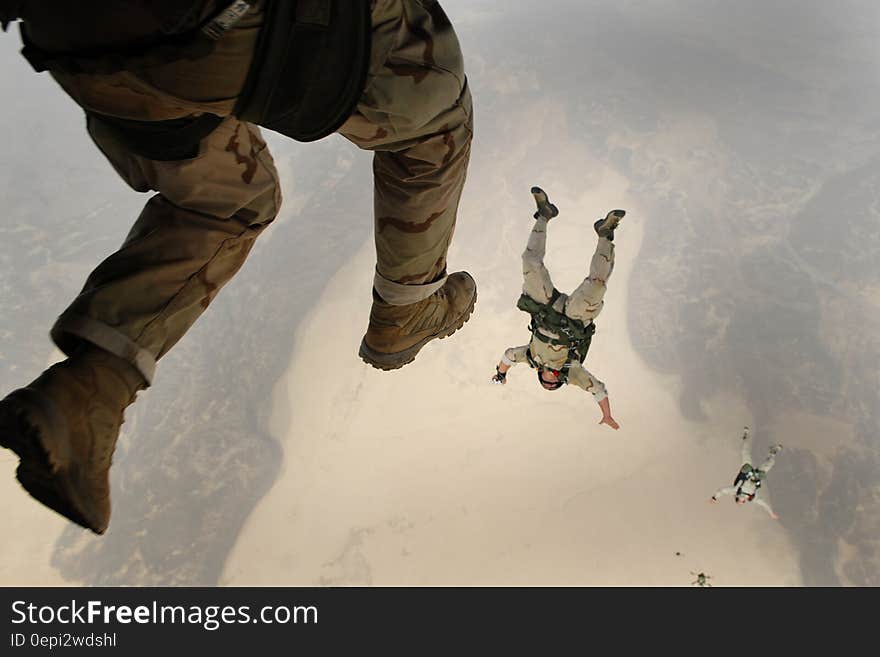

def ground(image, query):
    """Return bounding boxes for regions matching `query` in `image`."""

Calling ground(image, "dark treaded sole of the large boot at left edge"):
[0,390,106,534]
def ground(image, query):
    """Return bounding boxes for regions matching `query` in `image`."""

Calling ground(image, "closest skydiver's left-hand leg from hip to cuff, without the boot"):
[20,3,280,381]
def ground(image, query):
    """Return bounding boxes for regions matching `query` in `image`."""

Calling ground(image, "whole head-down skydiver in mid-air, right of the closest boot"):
[492,187,626,429]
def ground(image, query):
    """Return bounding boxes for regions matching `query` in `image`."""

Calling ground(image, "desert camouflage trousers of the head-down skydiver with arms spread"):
[522,218,614,323]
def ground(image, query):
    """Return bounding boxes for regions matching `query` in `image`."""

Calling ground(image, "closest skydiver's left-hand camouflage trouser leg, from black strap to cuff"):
[52,117,281,383]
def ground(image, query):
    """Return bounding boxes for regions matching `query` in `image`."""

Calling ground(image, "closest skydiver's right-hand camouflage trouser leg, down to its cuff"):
[339,0,473,305]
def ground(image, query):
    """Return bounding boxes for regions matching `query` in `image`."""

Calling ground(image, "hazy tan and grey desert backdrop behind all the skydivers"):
[0,0,880,585]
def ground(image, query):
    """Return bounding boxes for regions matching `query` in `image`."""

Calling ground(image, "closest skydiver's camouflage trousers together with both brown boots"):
[0,0,476,533]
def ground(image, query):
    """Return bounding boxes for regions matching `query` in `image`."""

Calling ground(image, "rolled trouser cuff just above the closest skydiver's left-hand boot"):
[49,313,156,387]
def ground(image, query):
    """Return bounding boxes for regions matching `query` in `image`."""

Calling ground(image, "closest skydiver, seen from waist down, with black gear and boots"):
[0,0,476,534]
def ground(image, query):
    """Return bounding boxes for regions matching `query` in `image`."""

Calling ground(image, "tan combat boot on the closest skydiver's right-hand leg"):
[359,271,477,370]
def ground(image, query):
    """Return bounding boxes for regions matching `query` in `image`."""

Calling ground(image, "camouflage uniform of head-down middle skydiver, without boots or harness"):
[501,216,614,402]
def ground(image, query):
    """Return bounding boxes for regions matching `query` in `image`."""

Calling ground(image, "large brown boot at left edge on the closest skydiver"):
[0,345,146,534]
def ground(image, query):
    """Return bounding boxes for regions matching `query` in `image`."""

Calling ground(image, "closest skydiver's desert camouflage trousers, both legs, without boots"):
[35,0,472,383]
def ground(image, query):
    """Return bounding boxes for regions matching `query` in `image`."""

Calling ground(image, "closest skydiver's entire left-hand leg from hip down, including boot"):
[0,3,280,533]
